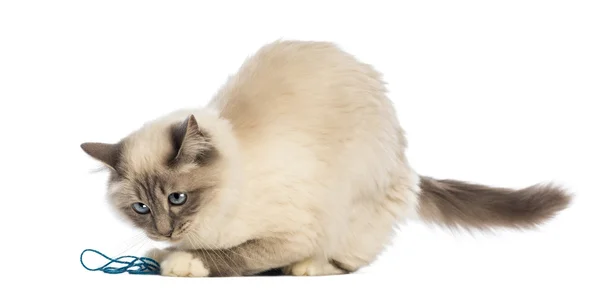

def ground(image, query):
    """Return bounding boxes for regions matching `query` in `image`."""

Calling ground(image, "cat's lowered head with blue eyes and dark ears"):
[81,112,238,242]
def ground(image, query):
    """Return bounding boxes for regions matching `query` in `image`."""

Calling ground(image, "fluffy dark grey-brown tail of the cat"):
[419,176,571,230]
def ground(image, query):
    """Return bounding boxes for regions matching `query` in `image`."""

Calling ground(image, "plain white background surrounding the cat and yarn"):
[0,0,600,289]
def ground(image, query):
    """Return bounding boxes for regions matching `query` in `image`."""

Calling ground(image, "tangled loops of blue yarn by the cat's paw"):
[79,249,160,275]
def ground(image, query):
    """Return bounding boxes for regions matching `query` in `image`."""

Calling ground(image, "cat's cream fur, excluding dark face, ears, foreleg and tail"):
[89,41,419,276]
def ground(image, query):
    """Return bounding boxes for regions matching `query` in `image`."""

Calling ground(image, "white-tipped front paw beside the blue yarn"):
[160,252,209,277]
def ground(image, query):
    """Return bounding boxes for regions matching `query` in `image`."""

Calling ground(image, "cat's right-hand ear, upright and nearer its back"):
[171,115,215,165]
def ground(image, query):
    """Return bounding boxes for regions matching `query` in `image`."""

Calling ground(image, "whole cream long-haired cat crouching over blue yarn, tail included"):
[81,40,571,277]
